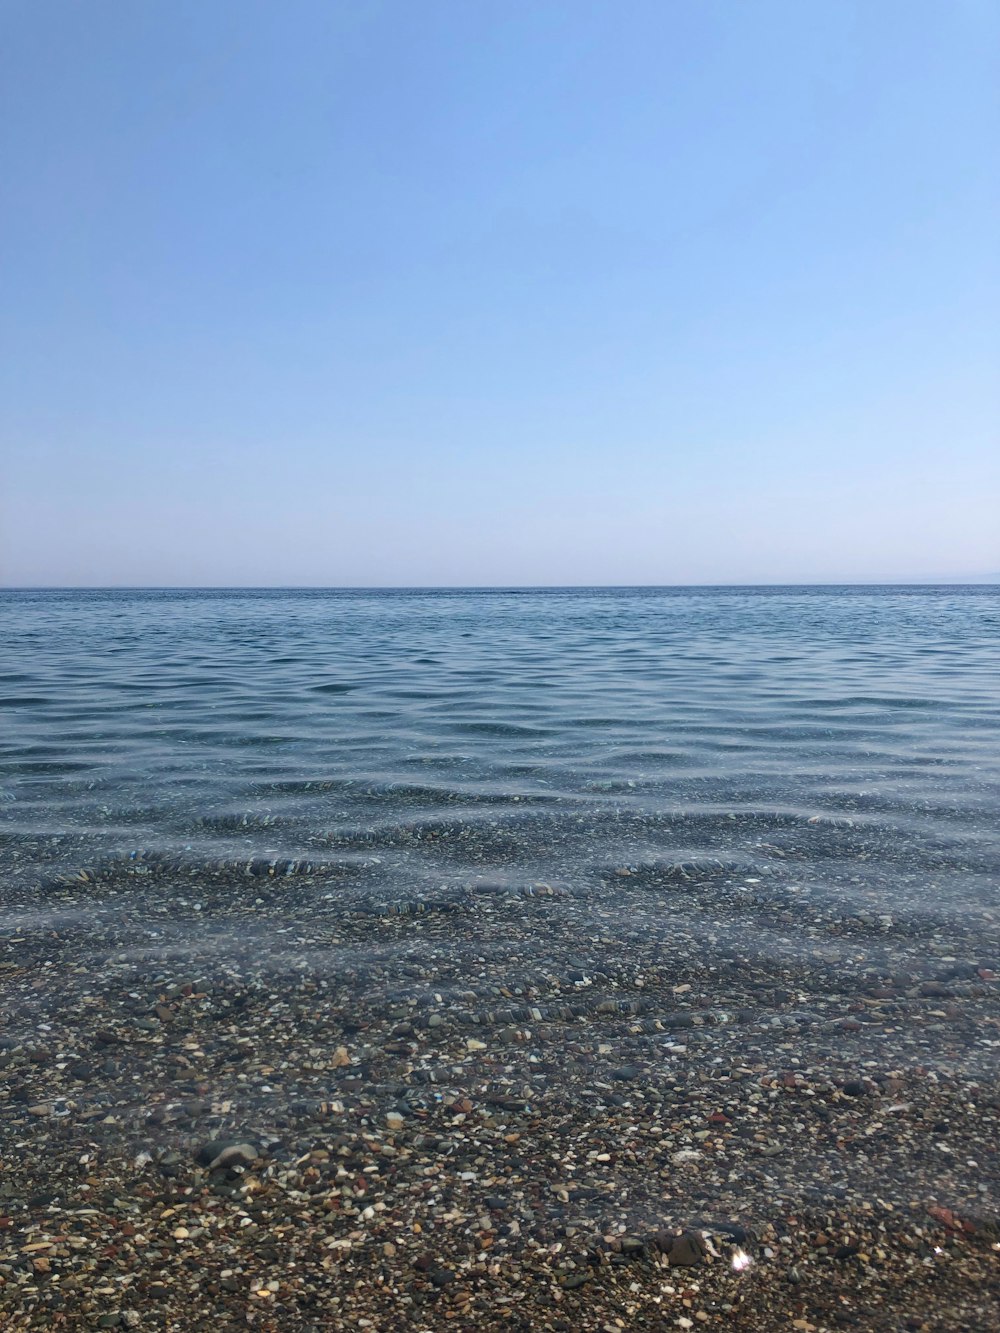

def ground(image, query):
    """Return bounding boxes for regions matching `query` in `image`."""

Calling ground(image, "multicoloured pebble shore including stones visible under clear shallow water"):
[0,857,1000,1333]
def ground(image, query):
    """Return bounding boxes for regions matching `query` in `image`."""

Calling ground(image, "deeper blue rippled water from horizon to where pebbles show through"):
[0,587,1000,917]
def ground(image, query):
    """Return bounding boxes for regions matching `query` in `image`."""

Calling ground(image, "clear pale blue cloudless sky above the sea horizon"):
[0,0,1000,585]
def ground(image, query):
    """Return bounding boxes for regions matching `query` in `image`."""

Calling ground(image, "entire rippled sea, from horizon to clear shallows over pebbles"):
[0,588,1000,1274]
